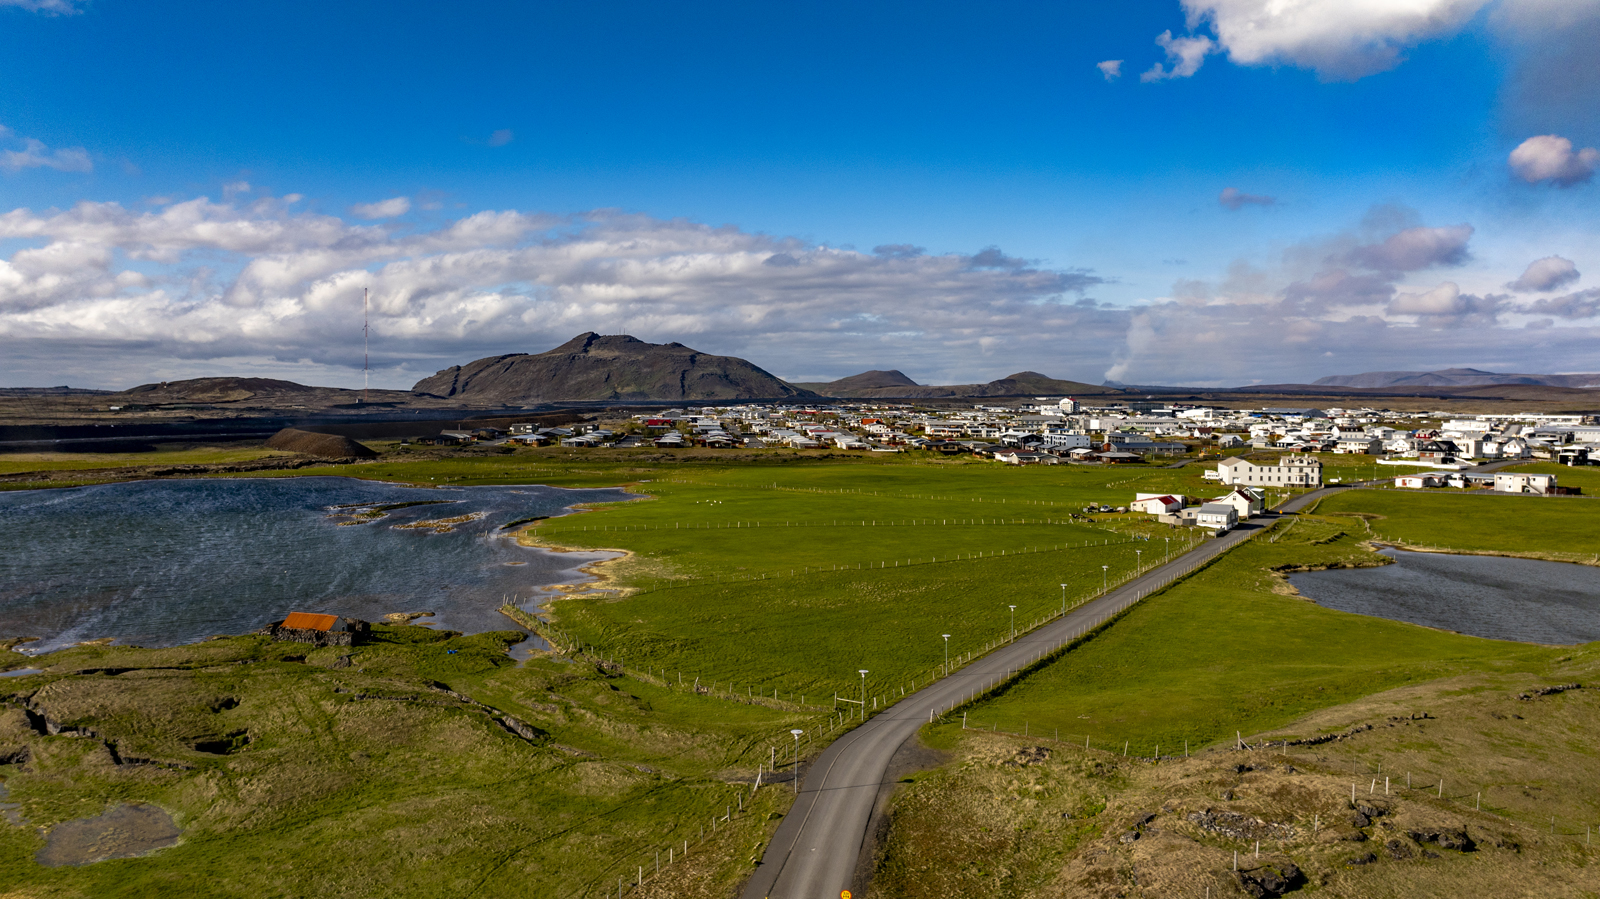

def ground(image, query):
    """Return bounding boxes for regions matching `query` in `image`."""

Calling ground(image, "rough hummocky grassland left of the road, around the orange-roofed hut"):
[0,625,811,897]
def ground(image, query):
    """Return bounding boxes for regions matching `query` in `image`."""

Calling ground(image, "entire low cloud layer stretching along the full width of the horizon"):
[0,186,1600,387]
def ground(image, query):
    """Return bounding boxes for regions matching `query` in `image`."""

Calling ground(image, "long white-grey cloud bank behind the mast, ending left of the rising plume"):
[0,190,1122,386]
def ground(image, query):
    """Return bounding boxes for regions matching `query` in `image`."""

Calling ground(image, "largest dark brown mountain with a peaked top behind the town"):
[413,331,816,399]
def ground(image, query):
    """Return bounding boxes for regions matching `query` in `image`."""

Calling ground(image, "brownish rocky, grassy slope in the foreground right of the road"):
[866,657,1600,899]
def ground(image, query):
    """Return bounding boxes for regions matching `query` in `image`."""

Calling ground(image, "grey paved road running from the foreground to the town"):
[744,488,1339,899]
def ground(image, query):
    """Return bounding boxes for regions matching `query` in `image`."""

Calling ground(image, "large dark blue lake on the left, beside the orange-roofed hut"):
[0,478,629,653]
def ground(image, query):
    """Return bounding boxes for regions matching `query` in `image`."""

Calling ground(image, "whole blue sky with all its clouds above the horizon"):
[0,0,1600,387]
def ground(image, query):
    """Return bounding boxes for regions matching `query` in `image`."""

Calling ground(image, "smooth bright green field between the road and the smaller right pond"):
[942,508,1566,755]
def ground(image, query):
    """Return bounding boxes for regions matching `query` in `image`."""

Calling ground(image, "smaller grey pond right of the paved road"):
[1290,549,1600,643]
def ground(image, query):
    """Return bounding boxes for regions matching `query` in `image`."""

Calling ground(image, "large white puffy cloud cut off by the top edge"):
[1182,0,1488,82]
